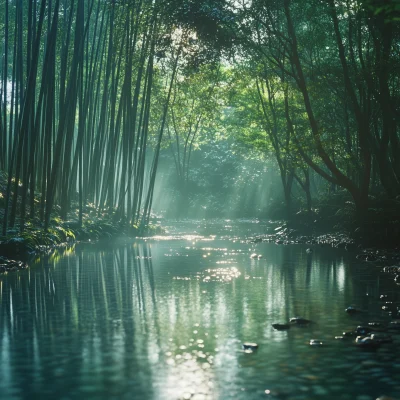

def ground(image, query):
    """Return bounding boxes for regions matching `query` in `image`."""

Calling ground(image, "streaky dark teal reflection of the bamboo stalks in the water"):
[0,244,160,398]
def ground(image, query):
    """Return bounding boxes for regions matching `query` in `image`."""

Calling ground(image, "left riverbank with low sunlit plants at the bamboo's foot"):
[0,171,166,273]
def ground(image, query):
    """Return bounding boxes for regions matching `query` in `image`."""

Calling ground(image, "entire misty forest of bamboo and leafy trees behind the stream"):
[0,0,400,234]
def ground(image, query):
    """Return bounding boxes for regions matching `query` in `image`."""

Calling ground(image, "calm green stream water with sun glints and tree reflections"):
[0,221,400,400]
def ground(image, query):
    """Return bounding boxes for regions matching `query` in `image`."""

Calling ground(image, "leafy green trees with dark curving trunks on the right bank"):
[225,0,400,217]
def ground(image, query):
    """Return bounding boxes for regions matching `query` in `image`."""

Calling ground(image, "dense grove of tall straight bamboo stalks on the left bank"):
[0,0,188,233]
